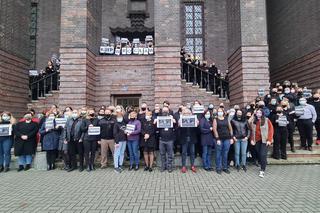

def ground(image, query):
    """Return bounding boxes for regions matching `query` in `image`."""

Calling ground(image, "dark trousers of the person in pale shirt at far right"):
[297,119,313,147]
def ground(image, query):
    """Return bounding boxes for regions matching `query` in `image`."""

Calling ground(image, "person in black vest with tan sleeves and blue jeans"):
[213,108,234,174]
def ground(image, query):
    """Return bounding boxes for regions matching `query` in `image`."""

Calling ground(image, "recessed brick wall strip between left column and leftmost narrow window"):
[36,0,61,70]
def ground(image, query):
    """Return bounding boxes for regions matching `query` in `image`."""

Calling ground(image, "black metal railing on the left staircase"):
[30,72,60,100]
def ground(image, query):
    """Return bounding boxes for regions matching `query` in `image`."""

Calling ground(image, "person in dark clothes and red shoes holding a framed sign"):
[179,108,199,173]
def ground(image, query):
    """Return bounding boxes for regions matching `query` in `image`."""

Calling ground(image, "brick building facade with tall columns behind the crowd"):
[0,0,320,113]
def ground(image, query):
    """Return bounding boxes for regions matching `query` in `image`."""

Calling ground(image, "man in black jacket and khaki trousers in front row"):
[98,109,115,169]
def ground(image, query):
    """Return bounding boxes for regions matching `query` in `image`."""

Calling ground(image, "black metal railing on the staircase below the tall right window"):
[181,60,229,99]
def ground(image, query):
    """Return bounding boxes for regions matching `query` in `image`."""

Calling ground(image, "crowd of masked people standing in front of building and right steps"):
[0,82,320,177]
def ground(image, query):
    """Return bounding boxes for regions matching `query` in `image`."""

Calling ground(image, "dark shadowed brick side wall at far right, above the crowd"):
[267,0,320,89]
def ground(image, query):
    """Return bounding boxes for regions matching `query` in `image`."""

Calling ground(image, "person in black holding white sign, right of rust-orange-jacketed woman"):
[270,106,289,160]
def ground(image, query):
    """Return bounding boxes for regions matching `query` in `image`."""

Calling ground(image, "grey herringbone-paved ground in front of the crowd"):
[0,165,320,213]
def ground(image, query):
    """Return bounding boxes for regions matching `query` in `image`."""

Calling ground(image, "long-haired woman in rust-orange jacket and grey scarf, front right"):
[250,109,274,178]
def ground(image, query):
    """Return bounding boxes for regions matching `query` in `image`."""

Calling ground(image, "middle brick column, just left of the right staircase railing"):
[154,0,182,108]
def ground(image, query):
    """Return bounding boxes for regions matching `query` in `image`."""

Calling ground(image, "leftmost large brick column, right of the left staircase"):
[59,0,101,107]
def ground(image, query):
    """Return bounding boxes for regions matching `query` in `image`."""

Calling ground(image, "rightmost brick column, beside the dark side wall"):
[227,0,270,105]
